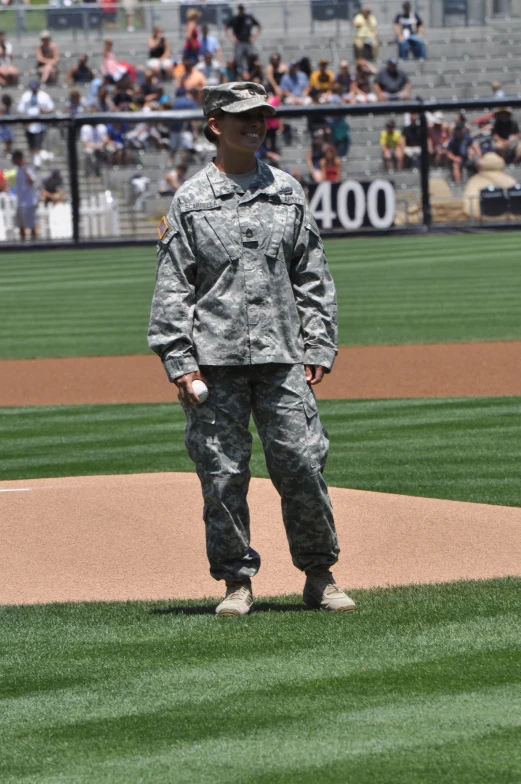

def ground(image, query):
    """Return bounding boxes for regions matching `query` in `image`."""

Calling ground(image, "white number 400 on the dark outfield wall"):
[309,180,396,230]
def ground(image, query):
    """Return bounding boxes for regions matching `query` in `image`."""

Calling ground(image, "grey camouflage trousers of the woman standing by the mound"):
[184,364,339,580]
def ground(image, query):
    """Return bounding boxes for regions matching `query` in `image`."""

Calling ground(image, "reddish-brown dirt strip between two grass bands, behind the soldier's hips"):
[0,341,521,406]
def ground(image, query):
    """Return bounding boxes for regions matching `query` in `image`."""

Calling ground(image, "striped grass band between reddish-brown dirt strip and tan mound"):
[0,397,521,506]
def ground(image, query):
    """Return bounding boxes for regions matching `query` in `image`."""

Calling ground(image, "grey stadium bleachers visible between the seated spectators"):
[0,14,521,237]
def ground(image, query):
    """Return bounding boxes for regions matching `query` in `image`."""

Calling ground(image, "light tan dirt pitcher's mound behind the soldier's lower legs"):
[0,473,521,604]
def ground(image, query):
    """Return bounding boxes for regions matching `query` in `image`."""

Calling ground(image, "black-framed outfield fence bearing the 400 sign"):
[0,98,521,244]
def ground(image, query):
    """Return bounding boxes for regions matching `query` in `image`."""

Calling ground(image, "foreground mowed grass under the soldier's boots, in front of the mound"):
[0,578,521,784]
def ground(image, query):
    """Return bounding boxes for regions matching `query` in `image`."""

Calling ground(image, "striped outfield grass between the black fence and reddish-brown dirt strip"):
[0,234,521,358]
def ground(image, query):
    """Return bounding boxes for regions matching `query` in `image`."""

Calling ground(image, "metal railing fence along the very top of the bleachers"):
[0,0,521,39]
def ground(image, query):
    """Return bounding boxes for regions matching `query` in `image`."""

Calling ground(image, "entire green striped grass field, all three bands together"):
[0,234,521,784]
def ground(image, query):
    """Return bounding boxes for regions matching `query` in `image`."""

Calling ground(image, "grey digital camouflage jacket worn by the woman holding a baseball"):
[148,162,337,381]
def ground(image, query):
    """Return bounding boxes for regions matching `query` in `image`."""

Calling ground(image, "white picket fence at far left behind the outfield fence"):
[0,191,120,242]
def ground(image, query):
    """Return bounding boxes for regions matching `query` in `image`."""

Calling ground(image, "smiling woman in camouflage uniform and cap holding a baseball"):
[149,82,355,616]
